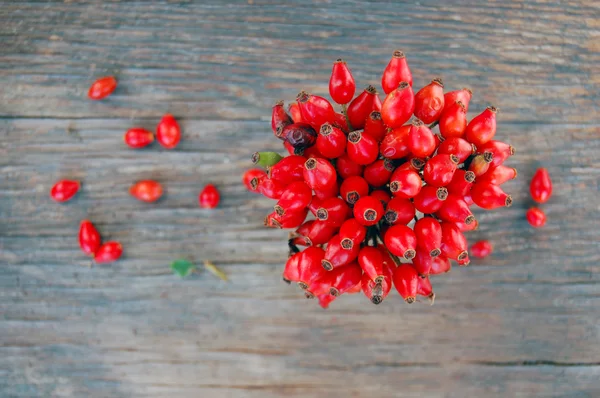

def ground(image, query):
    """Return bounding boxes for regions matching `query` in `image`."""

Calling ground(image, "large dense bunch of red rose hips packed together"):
[243,51,517,308]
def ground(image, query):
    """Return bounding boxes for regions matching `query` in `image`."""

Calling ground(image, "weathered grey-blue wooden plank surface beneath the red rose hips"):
[0,0,600,398]
